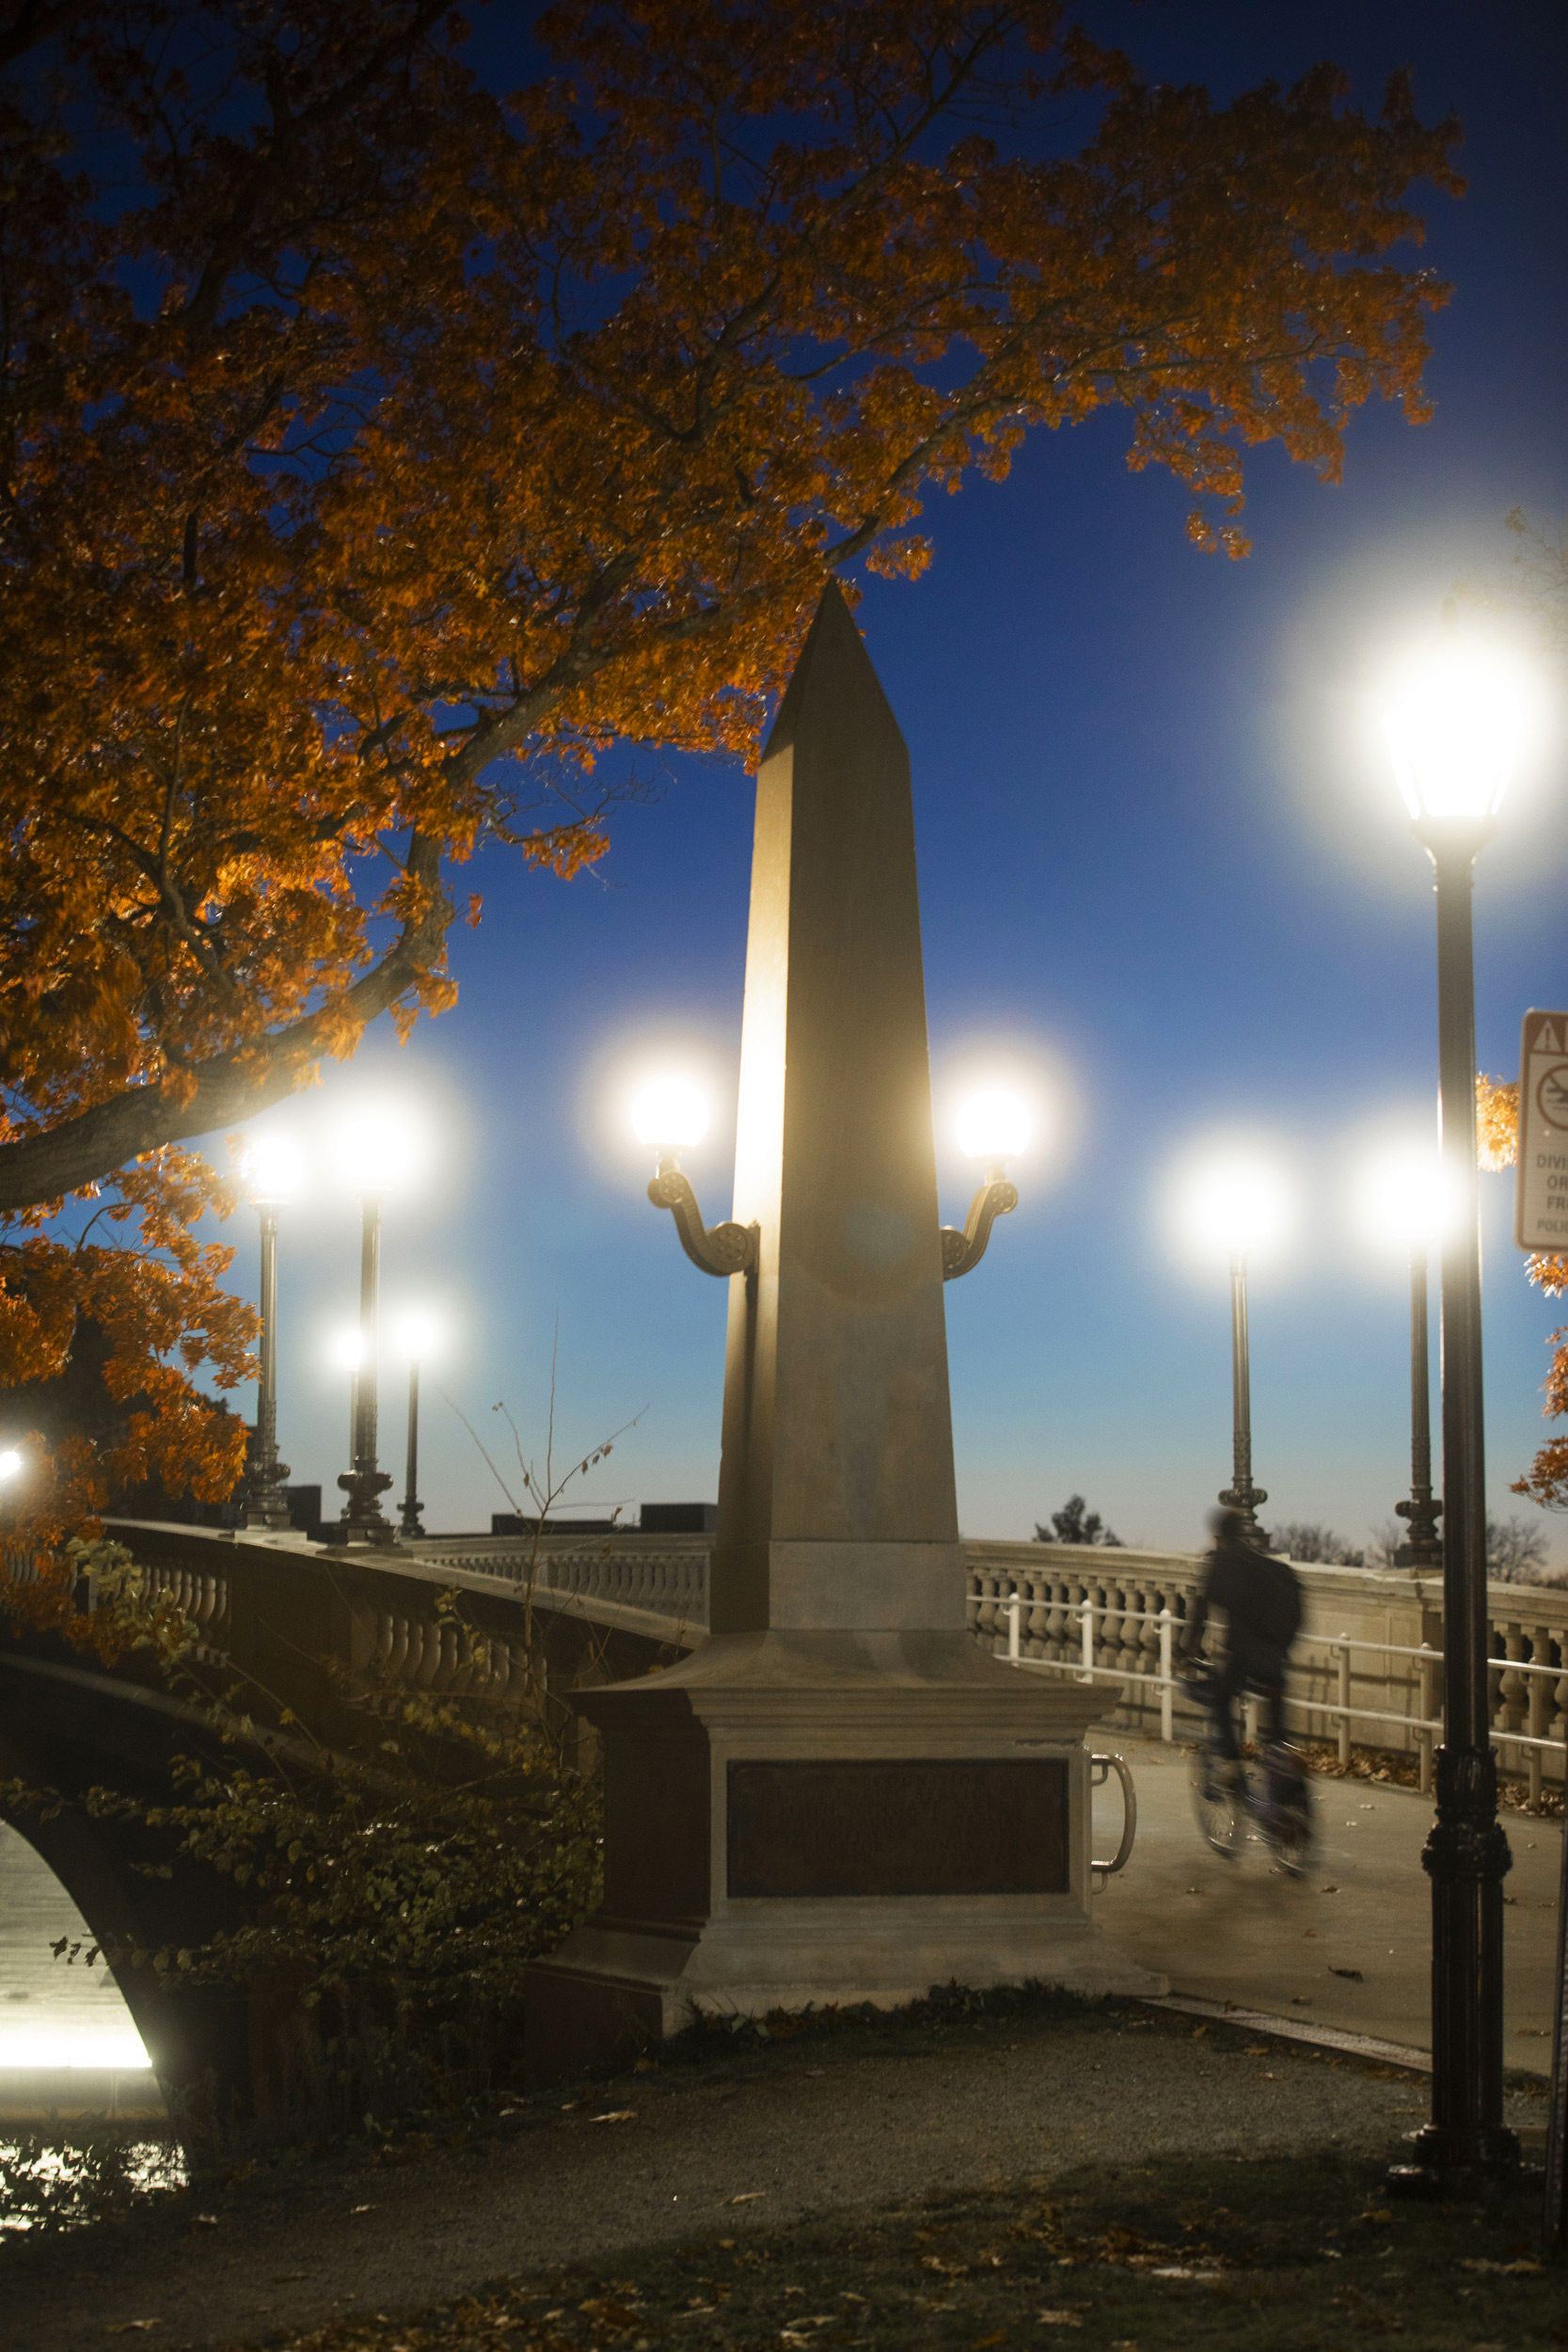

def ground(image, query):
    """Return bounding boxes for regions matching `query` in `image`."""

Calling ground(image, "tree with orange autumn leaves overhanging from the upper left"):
[0,0,1458,1510]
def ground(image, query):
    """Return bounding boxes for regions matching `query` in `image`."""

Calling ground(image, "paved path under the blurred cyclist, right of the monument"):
[1088,1726,1563,2073]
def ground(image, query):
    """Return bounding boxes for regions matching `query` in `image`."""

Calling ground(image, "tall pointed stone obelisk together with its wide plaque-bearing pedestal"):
[527,586,1164,2070]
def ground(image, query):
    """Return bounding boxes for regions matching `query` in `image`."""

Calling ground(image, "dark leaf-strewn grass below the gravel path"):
[247,2157,1568,2352]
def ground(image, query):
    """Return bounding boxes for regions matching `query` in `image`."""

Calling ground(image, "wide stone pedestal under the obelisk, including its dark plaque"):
[527,1632,1168,2079]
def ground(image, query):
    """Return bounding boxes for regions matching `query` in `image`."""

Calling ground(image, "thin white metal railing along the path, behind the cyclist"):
[992,1590,1568,1804]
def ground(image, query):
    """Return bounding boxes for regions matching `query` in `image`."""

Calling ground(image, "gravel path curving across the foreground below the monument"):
[0,1997,1543,2352]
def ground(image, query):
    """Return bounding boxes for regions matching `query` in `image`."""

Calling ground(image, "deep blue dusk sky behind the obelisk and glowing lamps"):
[242,0,1568,1557]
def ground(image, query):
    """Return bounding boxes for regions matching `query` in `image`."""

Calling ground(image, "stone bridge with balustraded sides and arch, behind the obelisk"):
[0,1522,1568,2115]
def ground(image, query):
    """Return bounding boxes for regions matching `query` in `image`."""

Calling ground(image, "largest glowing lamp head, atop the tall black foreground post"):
[1383,640,1530,828]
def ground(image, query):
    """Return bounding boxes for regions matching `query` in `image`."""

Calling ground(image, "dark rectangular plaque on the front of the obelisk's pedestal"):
[729,1757,1068,1896]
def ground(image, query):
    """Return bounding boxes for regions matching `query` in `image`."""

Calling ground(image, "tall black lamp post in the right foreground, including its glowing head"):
[1385,633,1519,2192]
